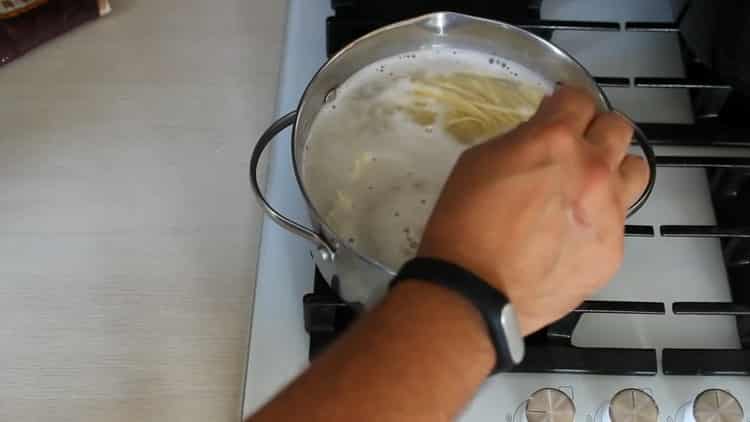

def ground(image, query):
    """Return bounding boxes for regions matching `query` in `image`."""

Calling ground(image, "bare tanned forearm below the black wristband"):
[250,282,495,422]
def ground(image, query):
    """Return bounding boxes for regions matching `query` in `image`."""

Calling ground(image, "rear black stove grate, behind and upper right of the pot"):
[326,0,750,146]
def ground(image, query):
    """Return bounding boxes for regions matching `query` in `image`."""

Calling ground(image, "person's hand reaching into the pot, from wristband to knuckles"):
[418,87,648,335]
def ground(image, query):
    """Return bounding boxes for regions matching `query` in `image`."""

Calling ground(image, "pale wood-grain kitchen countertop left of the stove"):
[0,0,286,422]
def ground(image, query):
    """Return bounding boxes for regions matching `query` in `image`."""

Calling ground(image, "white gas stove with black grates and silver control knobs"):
[244,0,750,422]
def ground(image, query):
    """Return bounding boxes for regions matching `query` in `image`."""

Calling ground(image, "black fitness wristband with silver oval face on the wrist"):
[391,258,524,374]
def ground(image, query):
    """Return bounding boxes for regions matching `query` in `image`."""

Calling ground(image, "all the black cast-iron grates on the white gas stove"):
[303,0,750,375]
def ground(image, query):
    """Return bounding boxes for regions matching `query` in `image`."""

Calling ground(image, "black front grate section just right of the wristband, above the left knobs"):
[513,300,665,375]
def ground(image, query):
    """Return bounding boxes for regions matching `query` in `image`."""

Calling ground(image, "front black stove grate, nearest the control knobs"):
[303,270,750,375]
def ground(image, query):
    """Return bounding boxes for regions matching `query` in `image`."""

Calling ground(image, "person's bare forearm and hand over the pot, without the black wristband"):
[251,87,648,422]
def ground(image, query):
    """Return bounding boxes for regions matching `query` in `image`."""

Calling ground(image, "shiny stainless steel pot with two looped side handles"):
[250,12,656,306]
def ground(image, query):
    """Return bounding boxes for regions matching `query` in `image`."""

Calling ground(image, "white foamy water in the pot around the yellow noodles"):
[303,48,552,270]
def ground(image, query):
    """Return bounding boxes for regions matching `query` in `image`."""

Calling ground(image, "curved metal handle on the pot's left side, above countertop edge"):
[250,111,334,260]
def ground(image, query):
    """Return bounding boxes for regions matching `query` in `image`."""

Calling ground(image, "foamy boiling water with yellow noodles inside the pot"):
[303,48,551,270]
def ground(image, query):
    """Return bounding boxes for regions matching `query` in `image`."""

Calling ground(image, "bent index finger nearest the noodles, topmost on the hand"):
[529,85,596,136]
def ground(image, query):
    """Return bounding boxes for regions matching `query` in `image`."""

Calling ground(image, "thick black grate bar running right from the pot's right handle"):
[638,123,750,147]
